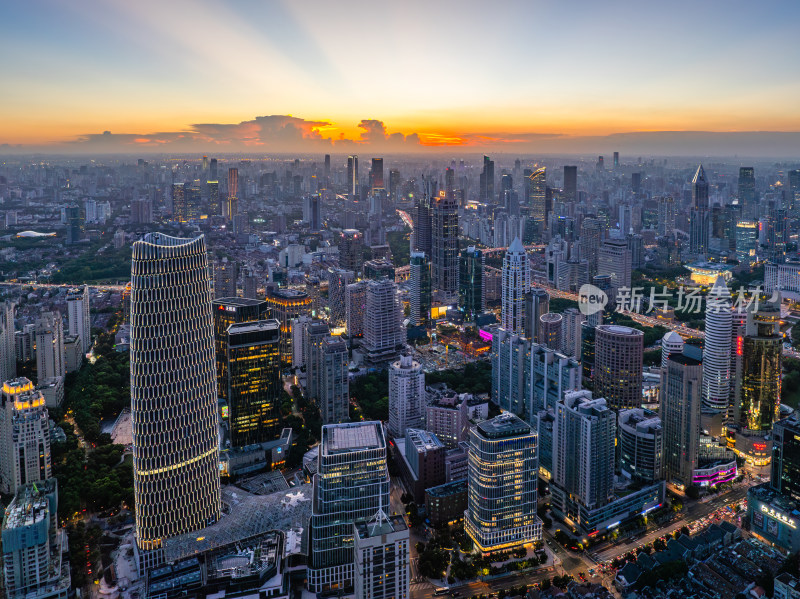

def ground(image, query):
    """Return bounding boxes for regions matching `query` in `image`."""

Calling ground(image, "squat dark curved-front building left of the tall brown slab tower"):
[617,408,664,483]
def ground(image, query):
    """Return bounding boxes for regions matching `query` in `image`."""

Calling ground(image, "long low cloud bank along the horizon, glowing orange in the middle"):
[0,115,800,158]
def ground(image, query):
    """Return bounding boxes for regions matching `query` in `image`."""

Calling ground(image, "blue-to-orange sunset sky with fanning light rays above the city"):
[0,0,800,151]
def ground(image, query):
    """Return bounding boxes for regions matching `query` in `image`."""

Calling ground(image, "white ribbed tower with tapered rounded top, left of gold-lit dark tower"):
[703,275,733,413]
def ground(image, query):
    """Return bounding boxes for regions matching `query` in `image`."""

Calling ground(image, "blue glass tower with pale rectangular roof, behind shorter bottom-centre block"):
[307,422,389,593]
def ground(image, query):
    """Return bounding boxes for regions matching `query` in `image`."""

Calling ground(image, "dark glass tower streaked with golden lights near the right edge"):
[734,292,783,436]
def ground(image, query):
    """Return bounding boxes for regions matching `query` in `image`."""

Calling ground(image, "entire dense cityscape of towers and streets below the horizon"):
[0,152,800,599]
